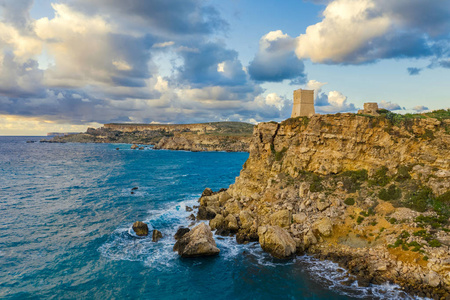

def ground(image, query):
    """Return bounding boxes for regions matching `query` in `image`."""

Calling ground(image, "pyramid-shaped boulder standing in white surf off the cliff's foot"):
[173,223,220,257]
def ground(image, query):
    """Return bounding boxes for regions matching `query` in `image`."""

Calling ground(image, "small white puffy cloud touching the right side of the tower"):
[305,80,356,114]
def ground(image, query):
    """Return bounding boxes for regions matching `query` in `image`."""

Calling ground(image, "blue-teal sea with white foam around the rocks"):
[0,137,420,299]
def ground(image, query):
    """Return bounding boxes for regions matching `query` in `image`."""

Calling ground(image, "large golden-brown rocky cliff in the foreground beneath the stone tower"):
[198,110,450,298]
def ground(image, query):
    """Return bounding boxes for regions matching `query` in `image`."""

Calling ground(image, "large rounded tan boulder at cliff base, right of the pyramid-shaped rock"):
[258,225,296,258]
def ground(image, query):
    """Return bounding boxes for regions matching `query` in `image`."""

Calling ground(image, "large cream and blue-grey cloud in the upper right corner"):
[296,0,450,64]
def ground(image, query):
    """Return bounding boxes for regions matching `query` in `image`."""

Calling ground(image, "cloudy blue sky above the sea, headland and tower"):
[0,0,450,135]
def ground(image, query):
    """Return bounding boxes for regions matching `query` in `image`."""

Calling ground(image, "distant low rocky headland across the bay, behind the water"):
[51,122,254,151]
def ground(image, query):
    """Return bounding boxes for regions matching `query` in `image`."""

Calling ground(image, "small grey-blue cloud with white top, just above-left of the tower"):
[248,30,306,84]
